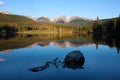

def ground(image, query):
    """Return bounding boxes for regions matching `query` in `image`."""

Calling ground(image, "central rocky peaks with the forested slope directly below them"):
[37,16,95,27]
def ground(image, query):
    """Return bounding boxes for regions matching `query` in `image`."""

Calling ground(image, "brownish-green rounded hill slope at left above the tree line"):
[0,13,34,23]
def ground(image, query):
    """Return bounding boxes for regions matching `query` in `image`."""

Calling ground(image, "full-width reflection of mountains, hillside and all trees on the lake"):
[0,34,120,53]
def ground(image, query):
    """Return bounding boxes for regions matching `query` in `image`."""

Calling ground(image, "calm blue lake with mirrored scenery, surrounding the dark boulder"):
[0,34,120,80]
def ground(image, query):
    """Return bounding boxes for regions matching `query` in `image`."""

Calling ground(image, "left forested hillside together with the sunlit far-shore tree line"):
[0,13,92,35]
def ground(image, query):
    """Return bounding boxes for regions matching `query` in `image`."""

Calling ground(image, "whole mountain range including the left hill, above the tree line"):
[0,11,117,27]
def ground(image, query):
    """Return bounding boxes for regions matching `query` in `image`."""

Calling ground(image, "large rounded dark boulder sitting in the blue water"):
[63,51,85,69]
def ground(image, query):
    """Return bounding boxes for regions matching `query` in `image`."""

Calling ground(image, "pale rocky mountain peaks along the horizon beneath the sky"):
[0,11,96,23]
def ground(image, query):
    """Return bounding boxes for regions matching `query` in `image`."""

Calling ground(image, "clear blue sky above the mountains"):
[0,0,120,18]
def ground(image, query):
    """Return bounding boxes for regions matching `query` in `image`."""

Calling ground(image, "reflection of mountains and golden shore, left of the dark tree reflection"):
[0,34,92,52]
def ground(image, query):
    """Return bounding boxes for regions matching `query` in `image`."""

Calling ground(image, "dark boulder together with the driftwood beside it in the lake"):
[29,51,85,72]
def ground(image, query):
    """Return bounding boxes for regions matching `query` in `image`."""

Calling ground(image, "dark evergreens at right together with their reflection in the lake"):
[93,17,120,52]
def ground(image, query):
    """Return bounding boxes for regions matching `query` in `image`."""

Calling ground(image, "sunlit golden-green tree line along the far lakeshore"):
[0,22,92,34]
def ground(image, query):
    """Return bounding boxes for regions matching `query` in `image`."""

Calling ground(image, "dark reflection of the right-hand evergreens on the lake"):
[92,34,120,53]
